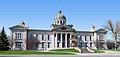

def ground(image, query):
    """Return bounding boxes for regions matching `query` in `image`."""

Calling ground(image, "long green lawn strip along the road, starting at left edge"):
[0,50,74,55]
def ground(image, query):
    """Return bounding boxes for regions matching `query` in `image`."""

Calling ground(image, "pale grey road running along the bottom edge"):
[0,54,120,57]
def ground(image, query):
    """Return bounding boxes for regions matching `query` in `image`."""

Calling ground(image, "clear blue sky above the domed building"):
[0,0,120,39]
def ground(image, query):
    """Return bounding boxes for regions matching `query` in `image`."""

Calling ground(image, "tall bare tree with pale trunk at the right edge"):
[104,20,120,50]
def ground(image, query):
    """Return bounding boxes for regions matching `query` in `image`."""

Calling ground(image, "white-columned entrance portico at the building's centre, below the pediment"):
[54,32,71,48]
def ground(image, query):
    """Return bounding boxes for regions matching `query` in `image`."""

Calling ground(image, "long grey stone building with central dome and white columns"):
[9,10,107,50]
